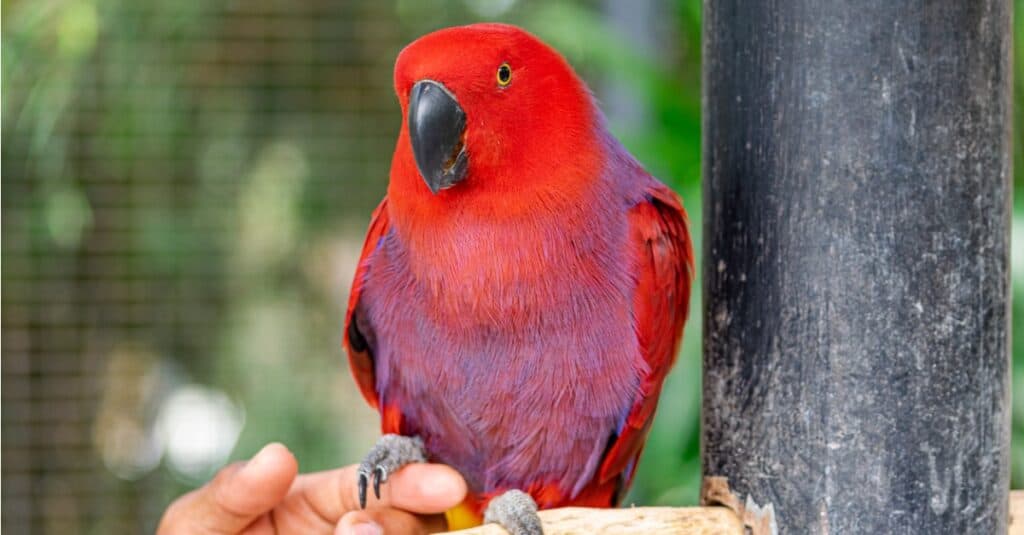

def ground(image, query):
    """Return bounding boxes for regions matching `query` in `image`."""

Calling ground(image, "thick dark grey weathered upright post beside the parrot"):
[703,0,1012,533]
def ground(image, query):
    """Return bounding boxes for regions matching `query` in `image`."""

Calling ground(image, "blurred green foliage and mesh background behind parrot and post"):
[2,0,1024,534]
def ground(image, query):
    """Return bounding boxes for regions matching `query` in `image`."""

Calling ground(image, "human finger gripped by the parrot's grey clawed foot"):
[296,463,466,524]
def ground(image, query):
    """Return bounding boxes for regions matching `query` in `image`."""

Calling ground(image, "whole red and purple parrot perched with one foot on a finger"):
[345,24,693,535]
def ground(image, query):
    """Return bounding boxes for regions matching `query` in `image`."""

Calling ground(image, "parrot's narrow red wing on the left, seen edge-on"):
[345,197,390,408]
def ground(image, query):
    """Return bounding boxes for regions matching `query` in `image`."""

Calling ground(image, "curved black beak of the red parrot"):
[409,80,469,194]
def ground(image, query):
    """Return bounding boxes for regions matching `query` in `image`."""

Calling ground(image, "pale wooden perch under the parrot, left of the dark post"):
[451,507,743,535]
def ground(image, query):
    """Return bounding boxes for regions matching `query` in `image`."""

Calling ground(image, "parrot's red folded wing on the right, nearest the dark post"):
[598,180,693,488]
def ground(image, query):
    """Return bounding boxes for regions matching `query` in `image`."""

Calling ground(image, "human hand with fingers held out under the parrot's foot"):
[157,443,466,535]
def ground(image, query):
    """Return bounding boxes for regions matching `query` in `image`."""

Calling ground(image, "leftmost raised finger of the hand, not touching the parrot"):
[161,444,298,534]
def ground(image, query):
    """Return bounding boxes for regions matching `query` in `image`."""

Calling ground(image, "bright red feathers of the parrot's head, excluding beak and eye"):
[388,24,599,228]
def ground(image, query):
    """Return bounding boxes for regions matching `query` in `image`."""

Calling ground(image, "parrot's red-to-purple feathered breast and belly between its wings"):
[362,179,643,507]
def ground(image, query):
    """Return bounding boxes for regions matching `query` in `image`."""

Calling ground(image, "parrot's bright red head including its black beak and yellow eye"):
[391,24,600,199]
